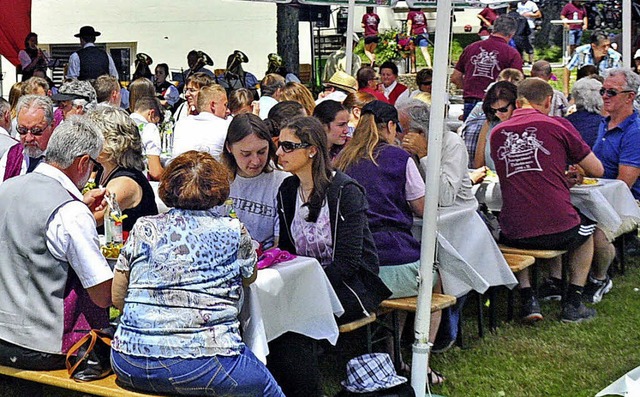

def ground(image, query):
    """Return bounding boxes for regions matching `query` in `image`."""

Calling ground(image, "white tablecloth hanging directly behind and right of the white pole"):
[413,204,518,297]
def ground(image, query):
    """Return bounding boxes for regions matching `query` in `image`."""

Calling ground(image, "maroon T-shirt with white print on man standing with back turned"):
[456,35,522,100]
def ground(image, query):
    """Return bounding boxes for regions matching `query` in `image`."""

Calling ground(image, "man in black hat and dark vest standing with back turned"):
[66,26,118,80]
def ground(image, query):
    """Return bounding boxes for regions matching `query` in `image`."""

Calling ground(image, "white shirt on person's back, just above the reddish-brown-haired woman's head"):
[171,112,231,160]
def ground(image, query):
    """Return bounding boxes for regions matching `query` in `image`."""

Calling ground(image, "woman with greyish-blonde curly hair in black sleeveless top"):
[88,105,158,234]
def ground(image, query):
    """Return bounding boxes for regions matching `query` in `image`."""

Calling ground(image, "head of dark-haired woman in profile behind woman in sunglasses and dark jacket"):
[313,100,349,161]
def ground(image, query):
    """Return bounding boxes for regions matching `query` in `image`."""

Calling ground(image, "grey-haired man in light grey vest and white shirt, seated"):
[0,117,113,370]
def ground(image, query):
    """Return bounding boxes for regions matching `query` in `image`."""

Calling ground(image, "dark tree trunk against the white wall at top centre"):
[277,4,300,76]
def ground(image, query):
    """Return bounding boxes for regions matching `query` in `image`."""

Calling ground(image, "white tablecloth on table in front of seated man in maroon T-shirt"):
[476,179,640,240]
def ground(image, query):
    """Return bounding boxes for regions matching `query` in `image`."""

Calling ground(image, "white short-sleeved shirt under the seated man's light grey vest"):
[33,163,113,288]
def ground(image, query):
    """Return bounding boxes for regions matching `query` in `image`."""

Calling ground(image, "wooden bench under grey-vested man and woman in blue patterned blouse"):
[0,365,162,397]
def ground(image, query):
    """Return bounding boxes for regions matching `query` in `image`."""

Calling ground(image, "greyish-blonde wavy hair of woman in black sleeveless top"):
[87,104,144,171]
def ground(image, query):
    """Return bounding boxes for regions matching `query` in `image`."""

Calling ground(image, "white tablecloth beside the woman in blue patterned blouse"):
[240,256,344,362]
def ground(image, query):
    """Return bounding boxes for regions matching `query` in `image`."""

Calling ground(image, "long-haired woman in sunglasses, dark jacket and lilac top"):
[267,116,391,397]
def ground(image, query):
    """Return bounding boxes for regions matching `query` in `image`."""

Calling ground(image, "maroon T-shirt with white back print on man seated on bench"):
[490,109,591,239]
